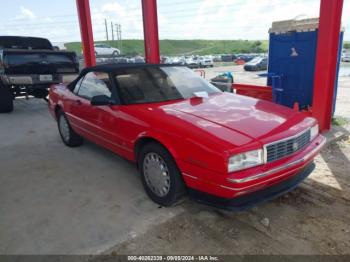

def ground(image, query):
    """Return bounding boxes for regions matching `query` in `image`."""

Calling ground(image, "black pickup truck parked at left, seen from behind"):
[0,36,79,113]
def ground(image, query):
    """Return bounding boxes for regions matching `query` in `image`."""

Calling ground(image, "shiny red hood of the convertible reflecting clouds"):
[163,93,306,140]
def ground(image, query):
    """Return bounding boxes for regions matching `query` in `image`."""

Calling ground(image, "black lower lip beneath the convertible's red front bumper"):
[189,162,315,211]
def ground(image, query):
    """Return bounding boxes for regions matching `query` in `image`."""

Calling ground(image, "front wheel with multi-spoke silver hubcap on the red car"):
[138,142,185,206]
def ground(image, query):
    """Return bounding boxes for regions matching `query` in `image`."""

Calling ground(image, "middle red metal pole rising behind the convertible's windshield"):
[141,0,160,64]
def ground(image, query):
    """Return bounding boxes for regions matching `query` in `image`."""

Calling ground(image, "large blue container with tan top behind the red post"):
[268,18,343,109]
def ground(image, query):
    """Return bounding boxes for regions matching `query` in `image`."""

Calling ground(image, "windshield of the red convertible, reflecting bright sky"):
[115,66,221,104]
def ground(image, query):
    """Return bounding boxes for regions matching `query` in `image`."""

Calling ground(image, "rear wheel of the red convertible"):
[57,111,84,147]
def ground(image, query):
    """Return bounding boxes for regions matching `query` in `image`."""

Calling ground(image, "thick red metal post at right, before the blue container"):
[312,0,343,132]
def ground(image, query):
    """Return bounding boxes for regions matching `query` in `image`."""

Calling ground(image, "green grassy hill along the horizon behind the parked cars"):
[66,39,268,56]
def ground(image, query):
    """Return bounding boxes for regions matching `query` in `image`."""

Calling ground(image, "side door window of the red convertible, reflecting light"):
[78,72,112,100]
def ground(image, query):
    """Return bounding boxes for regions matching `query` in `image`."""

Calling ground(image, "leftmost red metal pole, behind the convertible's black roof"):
[76,0,96,67]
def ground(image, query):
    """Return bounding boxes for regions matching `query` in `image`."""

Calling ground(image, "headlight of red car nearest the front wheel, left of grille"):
[228,149,264,172]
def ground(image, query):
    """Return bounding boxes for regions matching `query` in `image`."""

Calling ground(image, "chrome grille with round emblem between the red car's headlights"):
[265,130,311,163]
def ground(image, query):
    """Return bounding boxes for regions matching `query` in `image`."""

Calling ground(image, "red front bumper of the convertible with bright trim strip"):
[181,135,326,199]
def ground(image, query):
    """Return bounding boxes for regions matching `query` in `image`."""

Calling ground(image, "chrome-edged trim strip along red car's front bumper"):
[227,136,327,184]
